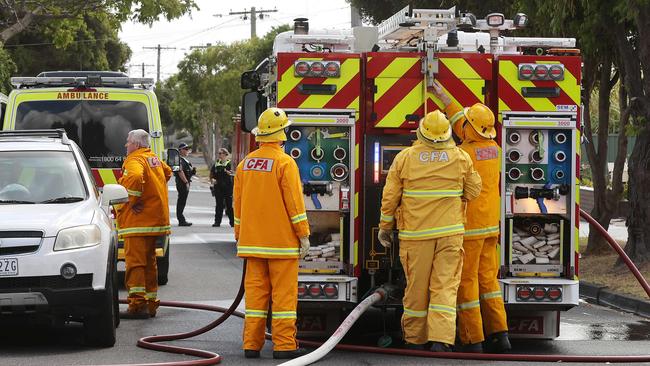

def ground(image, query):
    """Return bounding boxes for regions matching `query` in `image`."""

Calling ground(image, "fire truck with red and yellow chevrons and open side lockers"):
[233,6,581,339]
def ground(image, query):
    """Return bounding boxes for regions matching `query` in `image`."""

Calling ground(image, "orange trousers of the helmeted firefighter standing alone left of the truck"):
[244,257,298,351]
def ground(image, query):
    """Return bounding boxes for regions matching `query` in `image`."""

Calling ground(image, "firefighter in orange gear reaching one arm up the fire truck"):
[433,82,511,353]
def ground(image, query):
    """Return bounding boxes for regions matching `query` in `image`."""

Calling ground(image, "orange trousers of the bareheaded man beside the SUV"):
[124,236,160,313]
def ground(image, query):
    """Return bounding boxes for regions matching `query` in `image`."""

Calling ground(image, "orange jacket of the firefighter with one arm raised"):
[445,102,501,240]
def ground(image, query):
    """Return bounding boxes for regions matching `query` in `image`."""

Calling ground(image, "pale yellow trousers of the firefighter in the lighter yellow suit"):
[399,235,463,344]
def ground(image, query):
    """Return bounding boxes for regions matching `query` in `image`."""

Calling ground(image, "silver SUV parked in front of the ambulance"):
[0,130,127,347]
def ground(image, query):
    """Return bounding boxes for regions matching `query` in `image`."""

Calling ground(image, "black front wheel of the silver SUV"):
[84,271,119,347]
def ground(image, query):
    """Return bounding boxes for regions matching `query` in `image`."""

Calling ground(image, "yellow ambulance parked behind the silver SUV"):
[3,71,169,285]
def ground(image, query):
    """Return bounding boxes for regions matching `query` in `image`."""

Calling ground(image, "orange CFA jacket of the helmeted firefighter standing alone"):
[233,143,309,258]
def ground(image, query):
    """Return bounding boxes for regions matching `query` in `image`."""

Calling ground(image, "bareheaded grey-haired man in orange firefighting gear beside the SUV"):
[117,130,172,319]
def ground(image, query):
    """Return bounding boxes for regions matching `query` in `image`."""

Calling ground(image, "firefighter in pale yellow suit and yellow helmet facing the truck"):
[379,111,481,352]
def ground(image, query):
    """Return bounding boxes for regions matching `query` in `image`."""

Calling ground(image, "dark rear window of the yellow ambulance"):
[15,100,149,169]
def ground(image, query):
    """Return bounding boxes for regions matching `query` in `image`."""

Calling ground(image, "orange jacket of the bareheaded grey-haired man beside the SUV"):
[117,148,172,238]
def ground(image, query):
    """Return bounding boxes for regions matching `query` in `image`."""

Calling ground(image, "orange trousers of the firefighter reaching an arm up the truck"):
[458,236,508,344]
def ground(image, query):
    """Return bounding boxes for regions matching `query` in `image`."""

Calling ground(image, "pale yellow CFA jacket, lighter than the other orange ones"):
[379,140,481,240]
